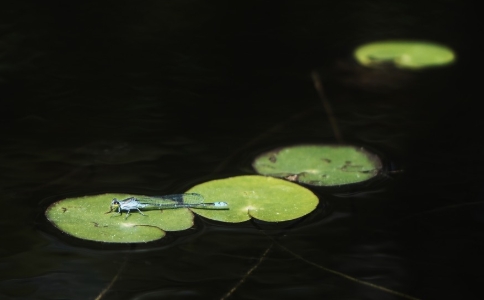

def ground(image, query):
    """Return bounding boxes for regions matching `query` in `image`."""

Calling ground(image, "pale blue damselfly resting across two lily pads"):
[106,193,229,219]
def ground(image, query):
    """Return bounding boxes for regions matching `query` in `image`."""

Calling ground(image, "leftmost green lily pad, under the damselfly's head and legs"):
[45,194,194,243]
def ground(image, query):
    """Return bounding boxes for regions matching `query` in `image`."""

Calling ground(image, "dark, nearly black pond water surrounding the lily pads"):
[0,1,484,299]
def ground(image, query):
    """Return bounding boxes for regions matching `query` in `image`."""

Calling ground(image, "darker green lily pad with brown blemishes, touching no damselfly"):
[252,145,382,186]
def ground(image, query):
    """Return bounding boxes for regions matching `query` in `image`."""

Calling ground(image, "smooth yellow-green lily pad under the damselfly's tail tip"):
[188,176,319,223]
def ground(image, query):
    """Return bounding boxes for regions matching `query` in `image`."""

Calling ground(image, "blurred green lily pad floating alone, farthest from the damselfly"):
[354,41,455,69]
